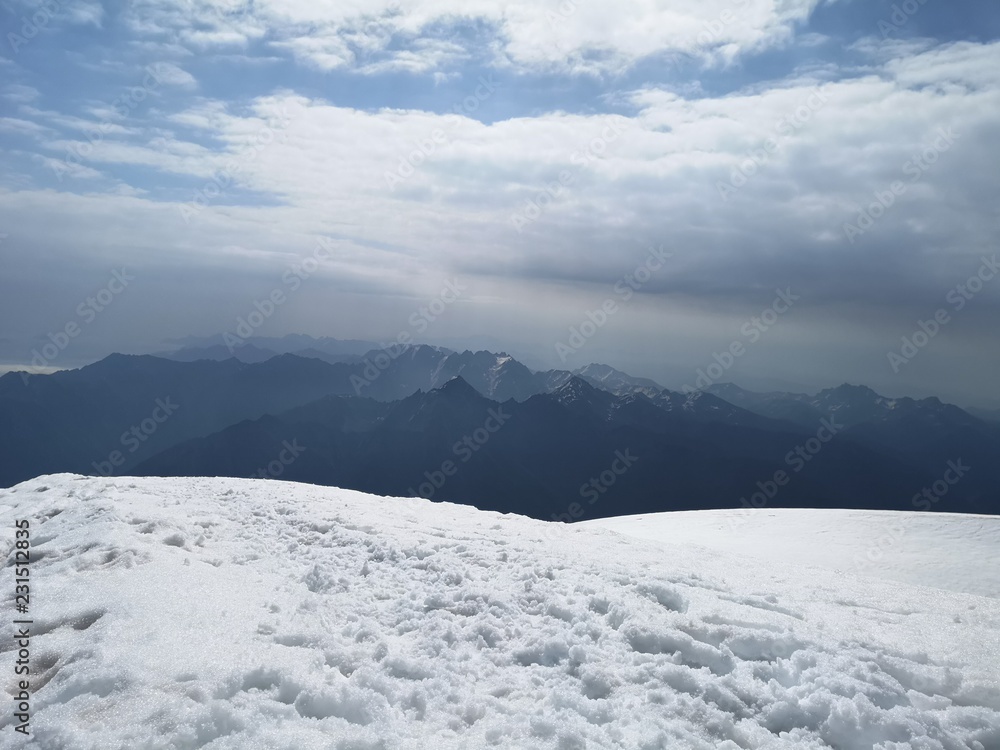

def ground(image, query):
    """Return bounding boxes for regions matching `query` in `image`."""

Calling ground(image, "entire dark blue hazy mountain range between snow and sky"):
[0,337,1000,521]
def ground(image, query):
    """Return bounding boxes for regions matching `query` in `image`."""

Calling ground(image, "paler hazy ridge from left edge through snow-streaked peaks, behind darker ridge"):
[0,354,776,492]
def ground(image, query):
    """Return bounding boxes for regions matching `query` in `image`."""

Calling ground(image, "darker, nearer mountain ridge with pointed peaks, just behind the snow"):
[131,376,944,520]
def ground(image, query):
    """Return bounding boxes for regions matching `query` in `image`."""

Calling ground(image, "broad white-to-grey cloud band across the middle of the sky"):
[0,38,1000,406]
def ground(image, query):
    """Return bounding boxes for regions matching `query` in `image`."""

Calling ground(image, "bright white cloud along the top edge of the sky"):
[123,0,819,74]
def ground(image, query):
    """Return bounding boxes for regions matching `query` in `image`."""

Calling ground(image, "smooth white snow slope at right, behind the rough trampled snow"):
[579,508,1000,598]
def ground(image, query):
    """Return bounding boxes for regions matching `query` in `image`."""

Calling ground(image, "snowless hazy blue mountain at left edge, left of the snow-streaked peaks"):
[0,354,362,485]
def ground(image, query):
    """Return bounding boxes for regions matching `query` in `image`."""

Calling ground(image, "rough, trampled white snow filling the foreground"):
[0,474,1000,750]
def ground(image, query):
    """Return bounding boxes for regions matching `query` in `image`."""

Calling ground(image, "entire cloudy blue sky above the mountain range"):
[0,0,1000,405]
